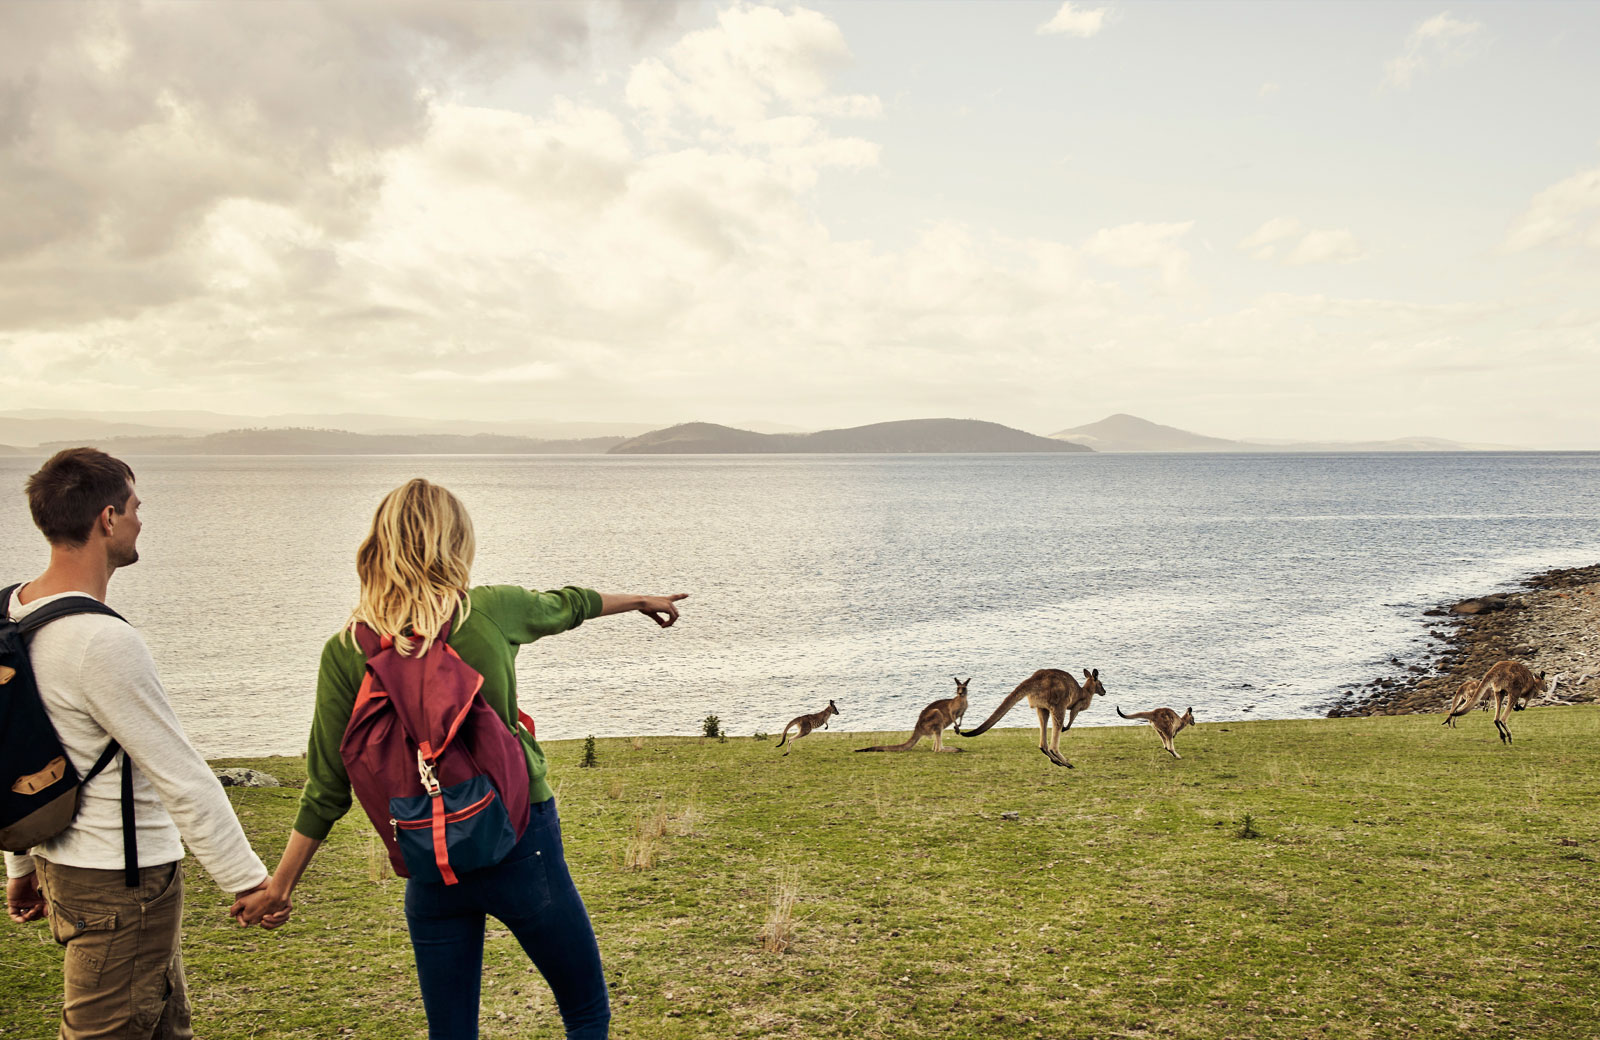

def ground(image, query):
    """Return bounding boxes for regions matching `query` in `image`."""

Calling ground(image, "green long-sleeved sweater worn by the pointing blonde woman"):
[294,586,600,842]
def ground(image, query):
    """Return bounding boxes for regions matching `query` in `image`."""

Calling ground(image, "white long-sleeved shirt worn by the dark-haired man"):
[5,592,267,893]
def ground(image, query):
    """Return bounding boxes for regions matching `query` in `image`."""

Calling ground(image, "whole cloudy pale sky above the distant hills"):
[0,0,1600,448]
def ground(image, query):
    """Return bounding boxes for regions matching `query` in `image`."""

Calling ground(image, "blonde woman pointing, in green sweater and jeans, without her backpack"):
[234,480,686,1040]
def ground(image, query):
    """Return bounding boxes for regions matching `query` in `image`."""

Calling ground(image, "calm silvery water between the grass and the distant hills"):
[0,453,1600,755]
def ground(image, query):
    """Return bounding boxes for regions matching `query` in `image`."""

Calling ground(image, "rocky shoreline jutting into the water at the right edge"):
[1328,565,1600,718]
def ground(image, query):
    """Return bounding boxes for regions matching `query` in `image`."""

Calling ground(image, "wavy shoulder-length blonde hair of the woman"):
[346,478,477,656]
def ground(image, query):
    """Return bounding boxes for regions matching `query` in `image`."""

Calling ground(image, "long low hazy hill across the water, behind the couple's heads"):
[38,429,624,454]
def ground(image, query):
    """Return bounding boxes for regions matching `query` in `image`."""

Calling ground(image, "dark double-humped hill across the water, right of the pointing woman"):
[611,419,1090,454]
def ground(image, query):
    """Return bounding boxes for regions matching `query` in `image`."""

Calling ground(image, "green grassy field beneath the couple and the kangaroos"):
[0,706,1600,1040]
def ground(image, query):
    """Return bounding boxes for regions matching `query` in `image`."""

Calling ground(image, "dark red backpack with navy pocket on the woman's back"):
[339,624,533,885]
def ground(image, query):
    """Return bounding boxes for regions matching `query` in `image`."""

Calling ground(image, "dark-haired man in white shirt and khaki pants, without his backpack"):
[3,448,267,1040]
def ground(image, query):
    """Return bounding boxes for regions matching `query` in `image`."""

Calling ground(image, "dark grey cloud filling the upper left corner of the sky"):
[0,0,681,325]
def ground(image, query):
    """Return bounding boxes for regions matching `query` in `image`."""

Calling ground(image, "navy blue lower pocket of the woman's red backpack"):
[389,774,517,885]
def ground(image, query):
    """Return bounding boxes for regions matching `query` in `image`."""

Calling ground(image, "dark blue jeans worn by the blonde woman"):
[405,798,611,1040]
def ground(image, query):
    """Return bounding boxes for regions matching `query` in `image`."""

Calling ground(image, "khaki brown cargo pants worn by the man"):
[35,858,194,1040]
